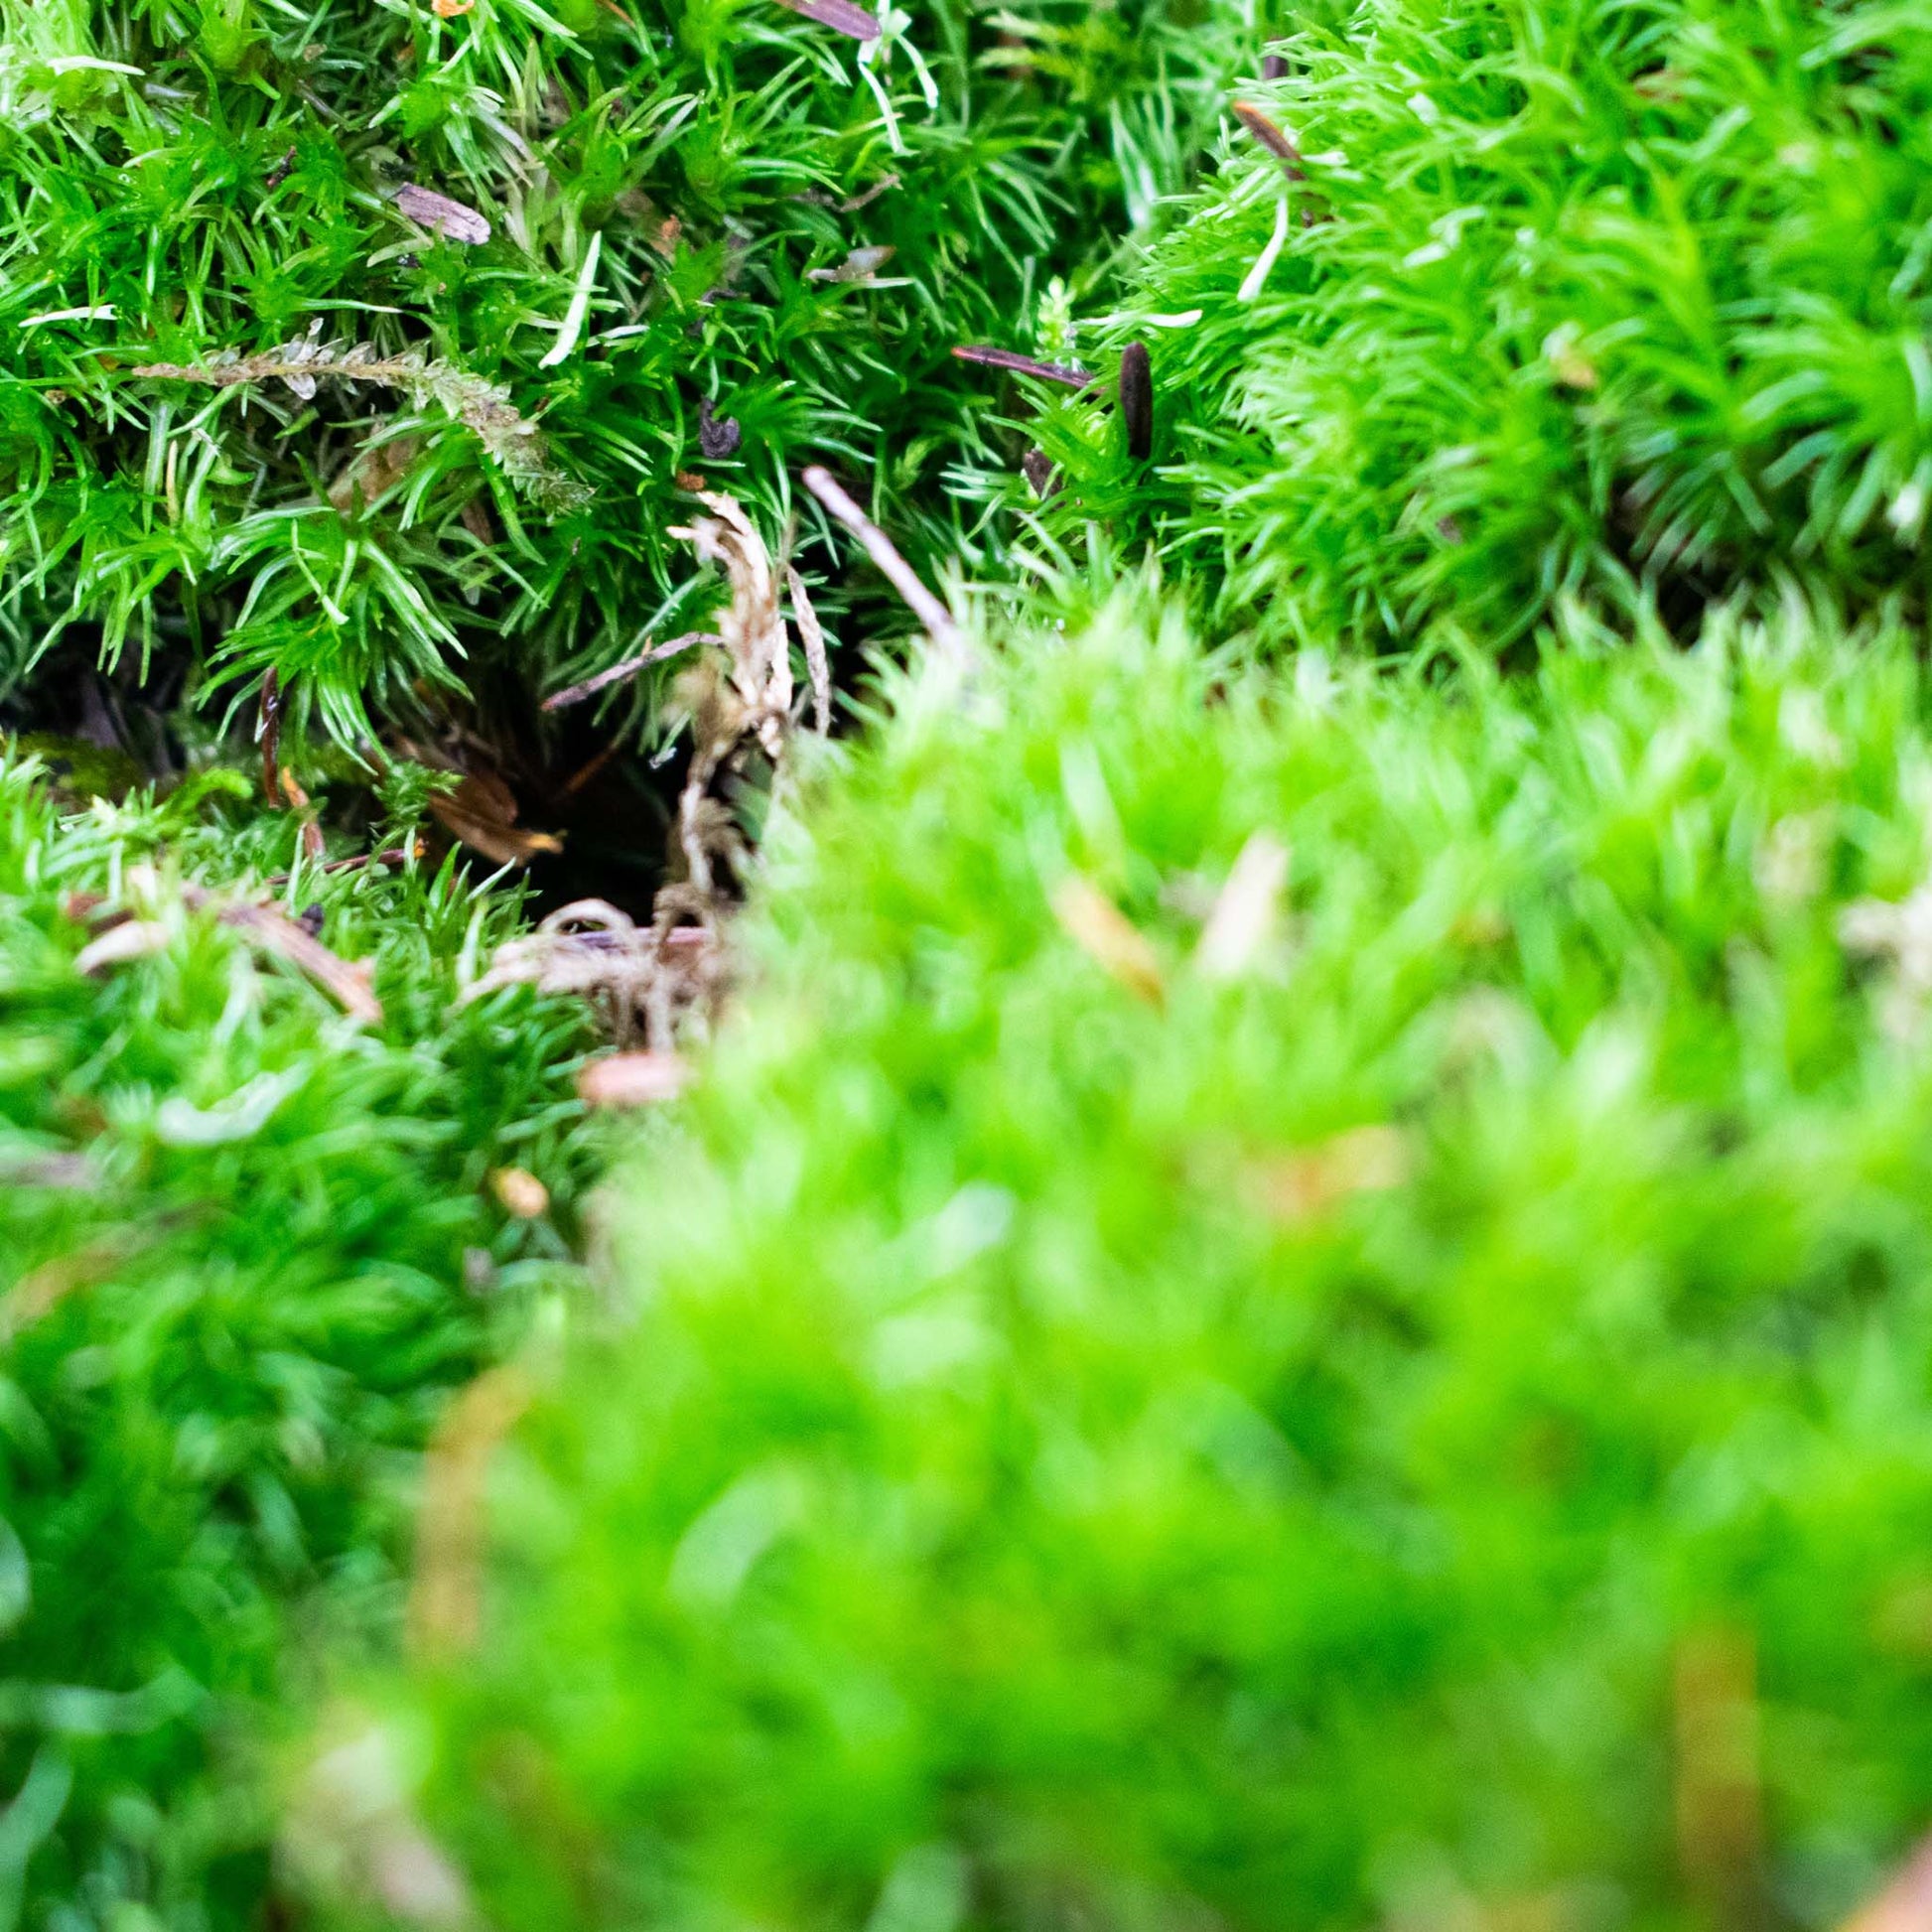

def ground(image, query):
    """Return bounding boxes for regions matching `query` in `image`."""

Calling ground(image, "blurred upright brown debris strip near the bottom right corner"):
[1671,1630,1766,1932]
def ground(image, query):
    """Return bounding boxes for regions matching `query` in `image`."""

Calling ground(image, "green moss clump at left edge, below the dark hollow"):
[0,759,591,1932]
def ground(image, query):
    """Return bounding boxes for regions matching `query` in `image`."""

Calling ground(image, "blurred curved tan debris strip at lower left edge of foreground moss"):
[410,1368,529,1664]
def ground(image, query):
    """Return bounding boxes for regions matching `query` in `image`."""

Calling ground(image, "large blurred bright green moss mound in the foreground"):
[324,605,1932,1932]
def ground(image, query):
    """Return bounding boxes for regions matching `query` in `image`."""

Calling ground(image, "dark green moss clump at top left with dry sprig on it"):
[0,0,1283,742]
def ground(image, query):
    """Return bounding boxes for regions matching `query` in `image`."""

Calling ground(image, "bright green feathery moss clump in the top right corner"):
[1003,0,1932,649]
